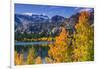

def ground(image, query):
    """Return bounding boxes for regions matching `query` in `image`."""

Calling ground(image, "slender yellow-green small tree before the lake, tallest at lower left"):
[27,47,35,64]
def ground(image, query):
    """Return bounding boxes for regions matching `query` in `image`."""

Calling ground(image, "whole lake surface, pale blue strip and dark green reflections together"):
[15,41,54,64]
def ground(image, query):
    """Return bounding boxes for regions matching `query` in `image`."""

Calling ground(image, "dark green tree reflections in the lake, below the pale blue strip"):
[15,45,49,63]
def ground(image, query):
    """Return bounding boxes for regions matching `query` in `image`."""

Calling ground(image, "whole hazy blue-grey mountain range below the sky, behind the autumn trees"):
[15,12,94,34]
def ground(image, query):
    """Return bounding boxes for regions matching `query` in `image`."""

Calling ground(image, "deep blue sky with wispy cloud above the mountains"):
[14,4,93,18]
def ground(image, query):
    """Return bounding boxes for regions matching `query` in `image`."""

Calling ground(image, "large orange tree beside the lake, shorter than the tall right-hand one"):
[48,27,68,62]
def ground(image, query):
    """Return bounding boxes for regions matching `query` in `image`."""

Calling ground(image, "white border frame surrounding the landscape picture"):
[10,0,96,69]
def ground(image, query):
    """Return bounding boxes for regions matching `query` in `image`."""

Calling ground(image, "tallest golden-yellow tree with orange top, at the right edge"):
[72,11,94,61]
